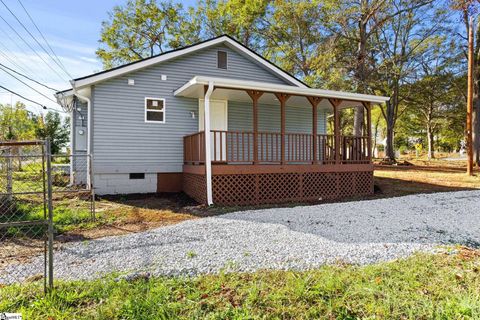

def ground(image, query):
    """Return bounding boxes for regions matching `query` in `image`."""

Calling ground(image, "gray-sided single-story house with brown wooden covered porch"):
[56,35,388,205]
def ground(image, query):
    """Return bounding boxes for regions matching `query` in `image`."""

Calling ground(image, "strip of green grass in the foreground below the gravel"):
[0,251,480,319]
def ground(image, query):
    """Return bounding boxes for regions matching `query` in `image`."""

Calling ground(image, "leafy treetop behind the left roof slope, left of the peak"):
[96,0,200,69]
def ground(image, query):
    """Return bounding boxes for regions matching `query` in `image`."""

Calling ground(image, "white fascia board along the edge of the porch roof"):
[174,76,390,103]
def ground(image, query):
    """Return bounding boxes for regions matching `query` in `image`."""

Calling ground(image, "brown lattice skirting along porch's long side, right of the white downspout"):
[212,171,373,205]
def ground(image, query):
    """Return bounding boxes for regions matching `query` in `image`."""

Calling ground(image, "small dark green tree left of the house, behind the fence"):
[35,111,70,154]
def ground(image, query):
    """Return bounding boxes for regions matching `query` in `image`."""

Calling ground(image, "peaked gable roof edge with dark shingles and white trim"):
[63,35,308,93]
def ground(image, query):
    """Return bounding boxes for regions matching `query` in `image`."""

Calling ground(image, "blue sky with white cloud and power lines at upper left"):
[0,0,195,113]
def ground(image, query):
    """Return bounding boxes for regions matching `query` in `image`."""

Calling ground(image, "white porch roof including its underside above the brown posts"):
[174,76,389,108]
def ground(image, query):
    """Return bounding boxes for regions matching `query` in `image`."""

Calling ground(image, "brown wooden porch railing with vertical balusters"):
[183,130,370,164]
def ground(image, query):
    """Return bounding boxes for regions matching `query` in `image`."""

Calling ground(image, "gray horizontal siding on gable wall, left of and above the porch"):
[92,46,298,173]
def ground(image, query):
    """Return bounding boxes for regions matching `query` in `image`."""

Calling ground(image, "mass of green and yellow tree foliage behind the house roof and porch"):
[97,0,472,156]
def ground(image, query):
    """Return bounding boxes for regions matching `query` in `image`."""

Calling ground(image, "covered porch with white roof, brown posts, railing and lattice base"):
[175,77,387,205]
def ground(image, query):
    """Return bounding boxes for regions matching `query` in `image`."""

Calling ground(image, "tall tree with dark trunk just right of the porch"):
[371,0,448,159]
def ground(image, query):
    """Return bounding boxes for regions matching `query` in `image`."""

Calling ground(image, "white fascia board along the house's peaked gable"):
[72,36,307,88]
